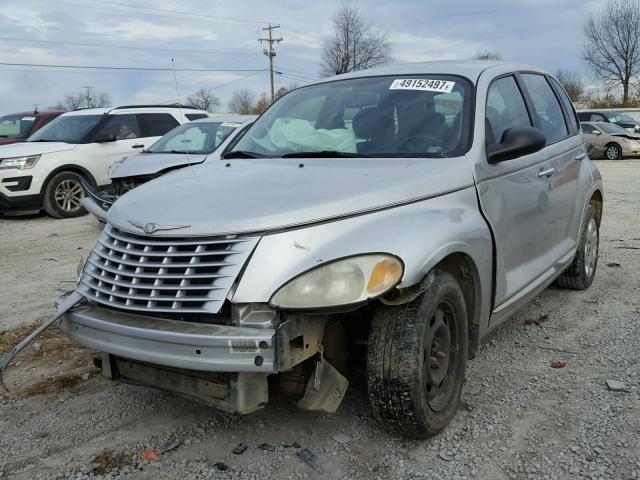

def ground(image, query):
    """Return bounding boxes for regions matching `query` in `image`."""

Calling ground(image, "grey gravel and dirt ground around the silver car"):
[0,161,640,480]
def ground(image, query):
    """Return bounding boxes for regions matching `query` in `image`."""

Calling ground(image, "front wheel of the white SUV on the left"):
[42,172,87,218]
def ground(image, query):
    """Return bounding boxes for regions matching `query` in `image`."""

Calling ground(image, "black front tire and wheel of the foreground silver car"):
[367,271,468,438]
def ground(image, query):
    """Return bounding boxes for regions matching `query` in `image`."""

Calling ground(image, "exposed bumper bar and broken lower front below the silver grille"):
[59,304,348,414]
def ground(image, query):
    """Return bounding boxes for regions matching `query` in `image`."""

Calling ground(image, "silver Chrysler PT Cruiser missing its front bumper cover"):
[59,62,603,437]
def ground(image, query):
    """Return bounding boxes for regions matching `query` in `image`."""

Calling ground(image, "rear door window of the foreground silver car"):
[522,73,569,143]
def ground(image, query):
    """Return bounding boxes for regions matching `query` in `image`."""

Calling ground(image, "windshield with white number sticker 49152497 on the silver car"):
[225,75,472,158]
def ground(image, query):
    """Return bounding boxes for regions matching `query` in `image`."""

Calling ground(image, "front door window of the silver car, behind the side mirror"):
[485,77,531,143]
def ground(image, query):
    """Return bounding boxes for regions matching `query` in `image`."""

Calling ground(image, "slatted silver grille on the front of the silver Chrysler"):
[80,225,258,313]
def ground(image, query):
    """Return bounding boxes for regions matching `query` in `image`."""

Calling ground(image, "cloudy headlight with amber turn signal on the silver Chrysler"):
[269,253,404,310]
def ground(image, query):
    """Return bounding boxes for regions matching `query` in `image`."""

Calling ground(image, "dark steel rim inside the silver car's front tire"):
[422,300,458,412]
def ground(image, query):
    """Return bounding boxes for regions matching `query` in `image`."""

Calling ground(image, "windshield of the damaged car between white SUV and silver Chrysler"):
[148,122,240,154]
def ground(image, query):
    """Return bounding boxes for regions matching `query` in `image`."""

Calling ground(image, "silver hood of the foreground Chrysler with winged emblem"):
[107,157,473,236]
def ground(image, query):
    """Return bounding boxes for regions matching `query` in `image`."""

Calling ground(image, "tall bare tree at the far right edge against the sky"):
[582,0,640,107]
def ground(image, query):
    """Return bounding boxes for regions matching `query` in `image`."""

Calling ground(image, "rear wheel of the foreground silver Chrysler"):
[556,205,600,290]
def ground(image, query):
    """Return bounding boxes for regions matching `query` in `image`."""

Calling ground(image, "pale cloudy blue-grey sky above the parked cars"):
[0,0,605,114]
